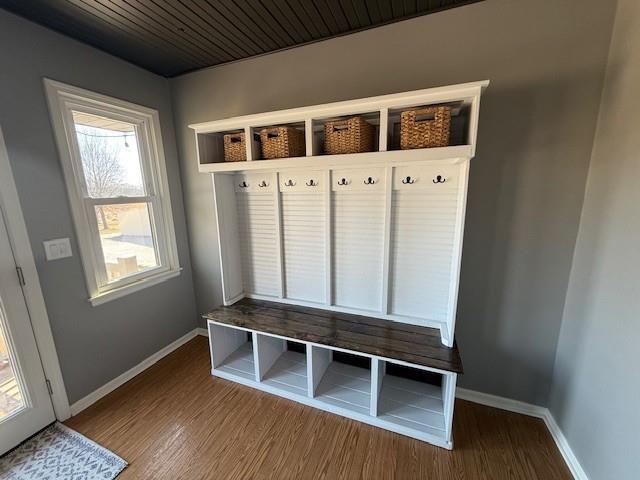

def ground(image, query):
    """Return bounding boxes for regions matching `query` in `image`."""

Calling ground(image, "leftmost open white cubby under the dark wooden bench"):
[209,323,255,380]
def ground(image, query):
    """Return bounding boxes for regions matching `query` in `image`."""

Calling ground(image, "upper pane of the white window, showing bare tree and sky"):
[73,112,145,198]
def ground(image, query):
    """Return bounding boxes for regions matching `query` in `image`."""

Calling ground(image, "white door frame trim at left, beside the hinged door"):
[0,126,71,421]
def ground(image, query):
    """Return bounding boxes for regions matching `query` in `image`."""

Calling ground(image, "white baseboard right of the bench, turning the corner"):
[456,387,589,480]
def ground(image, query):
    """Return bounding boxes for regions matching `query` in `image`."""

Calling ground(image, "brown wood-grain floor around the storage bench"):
[65,337,571,480]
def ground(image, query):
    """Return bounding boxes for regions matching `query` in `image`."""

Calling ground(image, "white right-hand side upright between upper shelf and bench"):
[440,159,469,347]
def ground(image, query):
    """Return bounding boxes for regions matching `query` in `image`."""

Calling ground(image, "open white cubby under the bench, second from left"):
[257,334,308,396]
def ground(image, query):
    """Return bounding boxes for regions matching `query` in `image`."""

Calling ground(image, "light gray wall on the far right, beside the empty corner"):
[550,0,640,480]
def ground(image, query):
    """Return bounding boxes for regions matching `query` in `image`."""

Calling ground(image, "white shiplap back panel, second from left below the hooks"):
[281,193,326,303]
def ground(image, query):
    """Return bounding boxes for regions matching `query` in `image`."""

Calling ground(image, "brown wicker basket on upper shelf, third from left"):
[324,117,375,155]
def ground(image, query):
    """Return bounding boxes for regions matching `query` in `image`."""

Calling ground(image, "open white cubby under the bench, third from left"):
[312,347,371,415]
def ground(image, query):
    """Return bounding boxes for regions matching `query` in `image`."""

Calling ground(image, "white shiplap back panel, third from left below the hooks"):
[332,192,385,311]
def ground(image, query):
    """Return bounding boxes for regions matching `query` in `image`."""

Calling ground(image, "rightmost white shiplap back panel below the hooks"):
[389,182,458,322]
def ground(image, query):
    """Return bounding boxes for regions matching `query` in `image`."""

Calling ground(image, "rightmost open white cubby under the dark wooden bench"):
[377,361,447,438]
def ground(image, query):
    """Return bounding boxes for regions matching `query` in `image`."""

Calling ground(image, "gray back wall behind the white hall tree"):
[171,0,615,405]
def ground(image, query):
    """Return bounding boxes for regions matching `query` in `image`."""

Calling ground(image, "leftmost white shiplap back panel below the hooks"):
[236,192,280,297]
